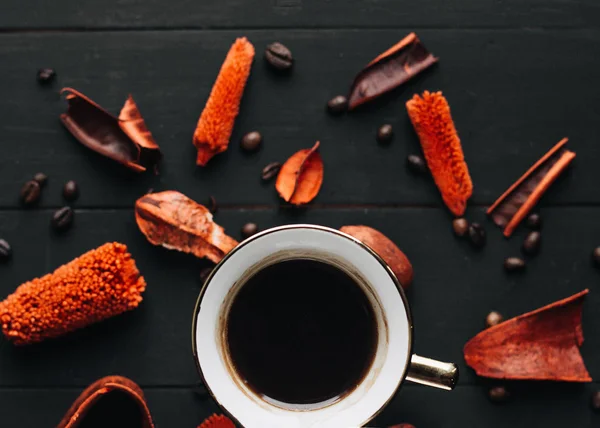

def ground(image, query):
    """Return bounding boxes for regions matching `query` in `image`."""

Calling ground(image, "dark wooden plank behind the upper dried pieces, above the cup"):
[0,30,600,207]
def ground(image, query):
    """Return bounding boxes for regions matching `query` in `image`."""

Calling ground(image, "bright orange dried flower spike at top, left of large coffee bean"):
[194,37,254,166]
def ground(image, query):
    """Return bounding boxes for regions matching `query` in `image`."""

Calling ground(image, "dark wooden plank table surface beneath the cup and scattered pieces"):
[0,0,600,428]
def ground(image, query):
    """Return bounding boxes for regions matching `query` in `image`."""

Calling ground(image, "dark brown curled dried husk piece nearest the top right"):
[348,33,438,110]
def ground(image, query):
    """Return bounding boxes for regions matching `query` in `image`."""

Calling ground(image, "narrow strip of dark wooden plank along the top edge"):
[0,0,599,29]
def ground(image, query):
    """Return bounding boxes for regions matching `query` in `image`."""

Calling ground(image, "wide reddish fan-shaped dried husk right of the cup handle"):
[464,290,592,382]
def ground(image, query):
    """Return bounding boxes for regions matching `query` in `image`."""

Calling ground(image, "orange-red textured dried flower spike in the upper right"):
[406,91,473,216]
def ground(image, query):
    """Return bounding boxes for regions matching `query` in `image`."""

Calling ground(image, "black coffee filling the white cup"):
[226,260,377,404]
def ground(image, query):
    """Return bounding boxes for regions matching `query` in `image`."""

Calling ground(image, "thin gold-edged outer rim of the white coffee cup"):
[191,223,414,426]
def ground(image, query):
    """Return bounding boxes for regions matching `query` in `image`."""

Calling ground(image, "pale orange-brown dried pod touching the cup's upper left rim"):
[135,190,238,263]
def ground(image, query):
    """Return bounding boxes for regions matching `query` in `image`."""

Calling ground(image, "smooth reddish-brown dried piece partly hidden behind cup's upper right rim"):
[340,226,413,289]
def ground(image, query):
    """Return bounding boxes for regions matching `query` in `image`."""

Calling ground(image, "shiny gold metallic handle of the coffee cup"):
[406,354,458,391]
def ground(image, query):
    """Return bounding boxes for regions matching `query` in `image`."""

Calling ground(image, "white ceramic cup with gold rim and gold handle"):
[192,225,458,428]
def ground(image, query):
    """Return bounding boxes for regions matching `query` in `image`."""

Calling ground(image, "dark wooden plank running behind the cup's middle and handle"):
[0,208,600,386]
